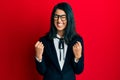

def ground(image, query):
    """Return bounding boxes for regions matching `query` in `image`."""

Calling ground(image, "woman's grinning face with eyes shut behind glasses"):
[54,9,67,32]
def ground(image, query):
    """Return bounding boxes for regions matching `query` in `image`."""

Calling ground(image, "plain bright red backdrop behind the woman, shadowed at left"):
[0,0,120,80]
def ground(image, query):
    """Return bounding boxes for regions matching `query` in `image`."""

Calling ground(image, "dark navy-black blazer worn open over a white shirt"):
[35,36,84,80]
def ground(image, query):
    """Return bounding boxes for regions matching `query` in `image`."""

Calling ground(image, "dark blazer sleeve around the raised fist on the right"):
[72,37,84,74]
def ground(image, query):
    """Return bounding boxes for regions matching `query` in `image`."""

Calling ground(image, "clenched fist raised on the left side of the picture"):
[35,41,44,60]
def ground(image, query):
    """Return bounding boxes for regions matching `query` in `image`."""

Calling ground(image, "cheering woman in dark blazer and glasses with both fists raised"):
[35,2,84,80]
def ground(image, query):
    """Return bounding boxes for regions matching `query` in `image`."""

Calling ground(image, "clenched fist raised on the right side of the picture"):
[73,41,82,59]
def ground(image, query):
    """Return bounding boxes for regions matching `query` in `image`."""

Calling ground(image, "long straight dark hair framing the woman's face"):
[48,2,76,44]
